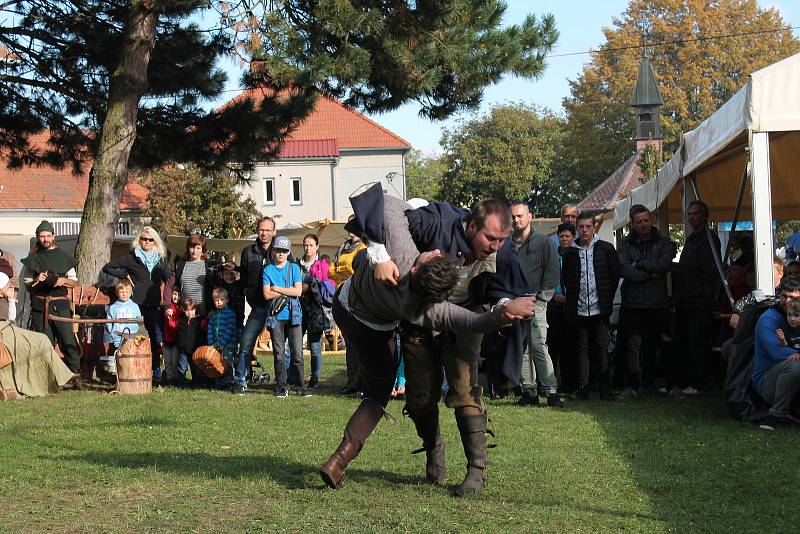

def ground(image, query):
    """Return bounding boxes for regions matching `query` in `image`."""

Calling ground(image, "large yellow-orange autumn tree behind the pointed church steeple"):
[563,0,800,197]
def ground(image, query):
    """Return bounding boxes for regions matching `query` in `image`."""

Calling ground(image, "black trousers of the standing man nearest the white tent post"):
[667,309,714,389]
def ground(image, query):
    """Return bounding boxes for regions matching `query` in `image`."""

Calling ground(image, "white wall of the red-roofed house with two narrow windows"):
[240,150,405,228]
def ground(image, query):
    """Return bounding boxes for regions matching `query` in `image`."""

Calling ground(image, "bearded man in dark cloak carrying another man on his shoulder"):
[350,184,528,496]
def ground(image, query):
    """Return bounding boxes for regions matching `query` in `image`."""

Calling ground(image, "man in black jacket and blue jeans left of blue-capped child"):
[233,217,293,395]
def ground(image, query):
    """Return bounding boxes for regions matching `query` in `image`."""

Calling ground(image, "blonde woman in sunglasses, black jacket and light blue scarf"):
[103,226,169,382]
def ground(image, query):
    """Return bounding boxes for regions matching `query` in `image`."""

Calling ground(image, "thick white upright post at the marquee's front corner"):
[749,130,775,295]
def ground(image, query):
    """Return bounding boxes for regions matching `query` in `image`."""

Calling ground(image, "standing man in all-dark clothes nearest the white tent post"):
[668,200,721,396]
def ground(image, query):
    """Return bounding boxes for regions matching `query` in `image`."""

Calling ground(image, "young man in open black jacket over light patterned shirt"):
[561,213,619,400]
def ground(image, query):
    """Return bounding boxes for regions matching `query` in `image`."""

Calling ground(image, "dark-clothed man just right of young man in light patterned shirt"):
[615,204,677,398]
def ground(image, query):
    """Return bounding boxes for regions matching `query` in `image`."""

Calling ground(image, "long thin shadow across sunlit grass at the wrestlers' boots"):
[52,452,419,489]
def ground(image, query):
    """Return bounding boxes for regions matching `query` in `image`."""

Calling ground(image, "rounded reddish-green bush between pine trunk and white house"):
[144,164,261,238]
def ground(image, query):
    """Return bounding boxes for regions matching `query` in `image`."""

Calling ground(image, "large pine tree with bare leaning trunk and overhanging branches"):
[0,0,558,281]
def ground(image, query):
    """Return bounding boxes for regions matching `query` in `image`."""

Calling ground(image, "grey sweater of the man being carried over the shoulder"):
[348,195,505,333]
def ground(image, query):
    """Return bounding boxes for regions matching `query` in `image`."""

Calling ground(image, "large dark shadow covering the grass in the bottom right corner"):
[571,394,800,532]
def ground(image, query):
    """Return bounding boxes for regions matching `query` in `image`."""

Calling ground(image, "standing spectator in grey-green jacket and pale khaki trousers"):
[511,202,564,408]
